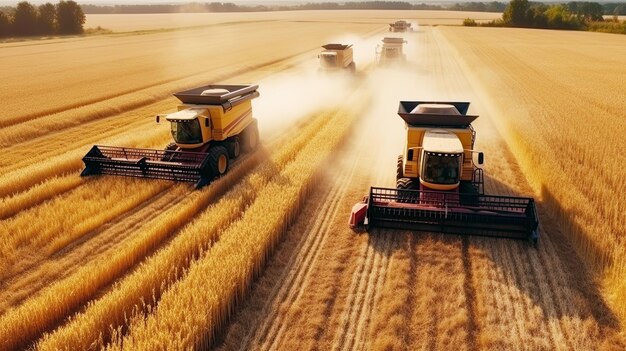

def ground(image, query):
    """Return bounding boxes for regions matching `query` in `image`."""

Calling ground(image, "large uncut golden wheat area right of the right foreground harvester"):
[444,29,626,326]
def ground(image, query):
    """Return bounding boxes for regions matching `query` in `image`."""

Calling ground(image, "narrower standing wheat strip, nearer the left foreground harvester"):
[33,110,336,350]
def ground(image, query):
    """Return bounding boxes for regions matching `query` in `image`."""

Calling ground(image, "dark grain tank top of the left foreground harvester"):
[174,84,259,105]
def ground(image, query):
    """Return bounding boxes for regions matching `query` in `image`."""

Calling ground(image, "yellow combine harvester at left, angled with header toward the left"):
[81,85,259,188]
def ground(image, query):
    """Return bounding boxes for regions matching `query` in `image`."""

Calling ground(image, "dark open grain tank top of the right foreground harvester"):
[398,101,478,127]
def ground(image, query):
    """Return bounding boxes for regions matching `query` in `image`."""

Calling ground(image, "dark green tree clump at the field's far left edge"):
[0,0,85,37]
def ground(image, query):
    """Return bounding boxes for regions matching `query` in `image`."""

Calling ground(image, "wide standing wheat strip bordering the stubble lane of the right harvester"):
[106,101,352,349]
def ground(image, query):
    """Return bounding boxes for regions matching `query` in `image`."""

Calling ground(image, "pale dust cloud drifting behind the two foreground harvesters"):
[254,28,472,171]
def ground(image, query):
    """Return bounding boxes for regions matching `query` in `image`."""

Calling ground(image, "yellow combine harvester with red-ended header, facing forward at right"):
[349,101,539,243]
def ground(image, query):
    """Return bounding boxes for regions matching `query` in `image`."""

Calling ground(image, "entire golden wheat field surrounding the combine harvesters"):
[0,11,626,350]
